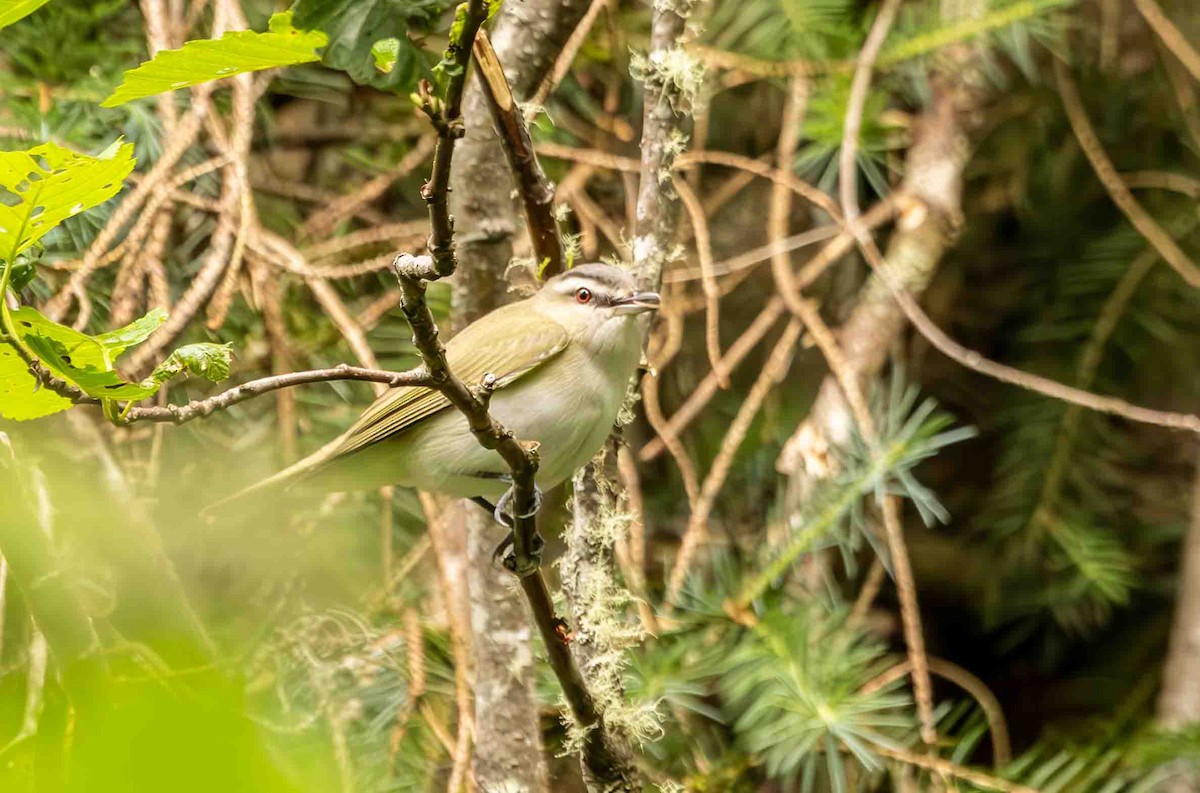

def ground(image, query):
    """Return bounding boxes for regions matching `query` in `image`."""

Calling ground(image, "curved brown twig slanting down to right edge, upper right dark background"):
[1054,60,1200,287]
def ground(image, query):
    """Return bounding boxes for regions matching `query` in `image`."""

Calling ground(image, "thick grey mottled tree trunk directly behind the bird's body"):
[450,0,588,791]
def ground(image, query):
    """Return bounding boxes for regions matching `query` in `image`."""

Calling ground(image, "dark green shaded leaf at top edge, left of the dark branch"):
[295,0,450,92]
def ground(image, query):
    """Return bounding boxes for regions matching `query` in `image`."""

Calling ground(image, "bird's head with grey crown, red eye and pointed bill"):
[534,263,660,347]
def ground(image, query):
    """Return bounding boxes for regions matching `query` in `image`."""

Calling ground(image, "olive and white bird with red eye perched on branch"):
[210,264,659,521]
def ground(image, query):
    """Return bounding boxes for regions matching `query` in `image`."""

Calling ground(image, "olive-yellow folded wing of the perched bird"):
[330,304,568,459]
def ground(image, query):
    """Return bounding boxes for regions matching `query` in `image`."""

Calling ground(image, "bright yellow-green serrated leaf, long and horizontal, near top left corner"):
[101,11,329,108]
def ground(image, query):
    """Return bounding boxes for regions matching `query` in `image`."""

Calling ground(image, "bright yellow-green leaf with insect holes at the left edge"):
[0,140,134,263]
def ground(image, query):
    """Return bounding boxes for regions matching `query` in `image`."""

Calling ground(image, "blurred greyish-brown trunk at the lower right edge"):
[1157,446,1200,793]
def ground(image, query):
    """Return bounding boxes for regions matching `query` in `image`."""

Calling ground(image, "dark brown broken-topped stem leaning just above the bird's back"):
[474,30,566,277]
